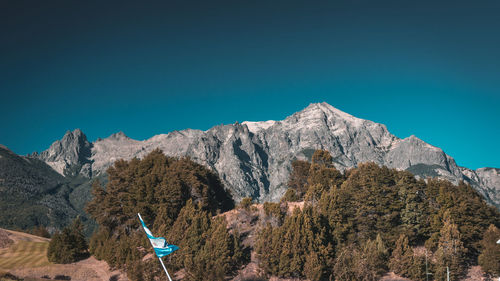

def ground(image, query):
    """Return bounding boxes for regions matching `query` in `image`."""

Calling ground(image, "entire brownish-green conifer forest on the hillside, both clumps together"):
[87,150,500,280]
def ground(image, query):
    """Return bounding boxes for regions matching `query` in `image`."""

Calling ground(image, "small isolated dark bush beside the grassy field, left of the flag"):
[47,218,88,263]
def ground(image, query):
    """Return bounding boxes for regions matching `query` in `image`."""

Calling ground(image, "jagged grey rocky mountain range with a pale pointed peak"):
[34,103,500,206]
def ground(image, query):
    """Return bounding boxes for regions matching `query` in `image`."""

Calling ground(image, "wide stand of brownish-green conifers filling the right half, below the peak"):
[255,150,500,280]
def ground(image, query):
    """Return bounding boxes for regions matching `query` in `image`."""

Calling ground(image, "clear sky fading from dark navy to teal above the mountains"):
[0,0,500,168]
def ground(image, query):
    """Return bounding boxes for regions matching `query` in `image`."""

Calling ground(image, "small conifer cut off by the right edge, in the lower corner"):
[478,225,500,276]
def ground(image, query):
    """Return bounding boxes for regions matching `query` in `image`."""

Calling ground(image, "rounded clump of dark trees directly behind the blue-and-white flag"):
[87,150,239,280]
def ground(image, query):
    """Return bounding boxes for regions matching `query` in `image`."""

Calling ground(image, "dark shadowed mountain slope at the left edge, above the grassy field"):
[0,146,77,229]
